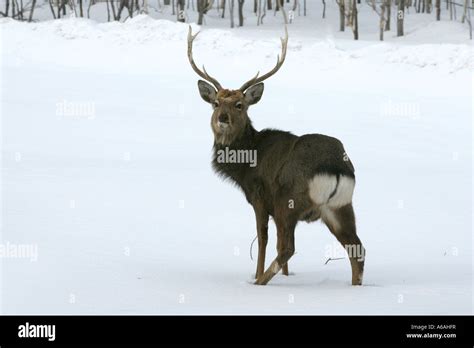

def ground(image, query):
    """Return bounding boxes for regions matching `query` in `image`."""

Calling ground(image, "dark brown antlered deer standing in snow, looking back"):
[187,25,365,285]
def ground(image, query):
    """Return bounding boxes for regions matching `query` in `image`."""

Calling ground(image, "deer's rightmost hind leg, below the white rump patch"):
[321,203,365,285]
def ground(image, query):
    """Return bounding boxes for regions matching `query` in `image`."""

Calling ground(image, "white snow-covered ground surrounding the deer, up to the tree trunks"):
[0,5,473,314]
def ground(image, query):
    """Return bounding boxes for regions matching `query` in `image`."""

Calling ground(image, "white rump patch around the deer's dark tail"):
[309,174,355,208]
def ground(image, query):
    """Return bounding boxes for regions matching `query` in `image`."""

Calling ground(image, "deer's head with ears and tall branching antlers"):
[188,26,288,145]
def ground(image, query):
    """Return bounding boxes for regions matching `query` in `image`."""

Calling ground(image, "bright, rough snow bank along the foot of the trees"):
[0,15,473,73]
